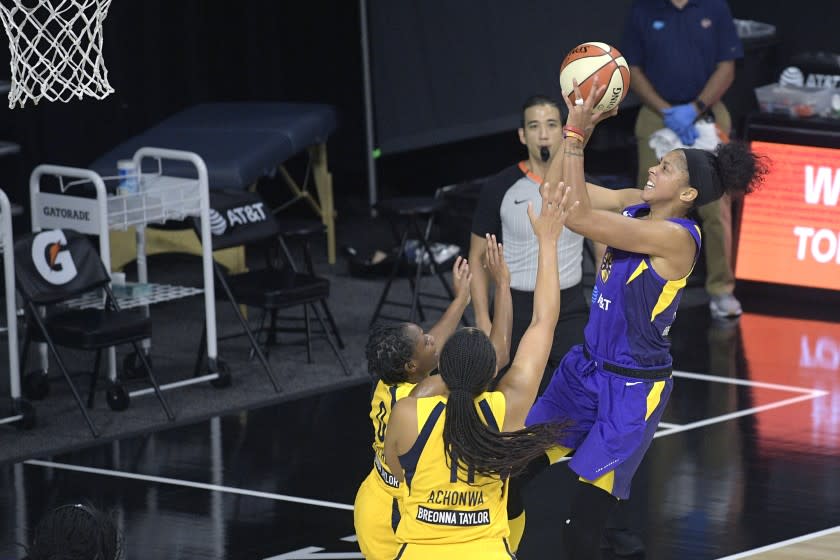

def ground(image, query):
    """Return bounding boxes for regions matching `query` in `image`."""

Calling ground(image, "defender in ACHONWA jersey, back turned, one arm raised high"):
[385,185,569,560]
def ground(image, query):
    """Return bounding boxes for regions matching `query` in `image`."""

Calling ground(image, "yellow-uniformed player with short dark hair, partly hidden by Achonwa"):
[353,250,506,559]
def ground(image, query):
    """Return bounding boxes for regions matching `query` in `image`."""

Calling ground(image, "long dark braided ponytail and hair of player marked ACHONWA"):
[440,328,563,481]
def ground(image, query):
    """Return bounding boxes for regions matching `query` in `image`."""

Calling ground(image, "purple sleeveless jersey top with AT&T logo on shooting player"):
[584,204,700,368]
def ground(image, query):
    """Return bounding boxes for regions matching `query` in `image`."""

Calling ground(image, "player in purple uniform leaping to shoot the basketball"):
[527,79,766,560]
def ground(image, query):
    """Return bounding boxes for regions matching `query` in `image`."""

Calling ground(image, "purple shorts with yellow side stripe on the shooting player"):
[525,345,674,500]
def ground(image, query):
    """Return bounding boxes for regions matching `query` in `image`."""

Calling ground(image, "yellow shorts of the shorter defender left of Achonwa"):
[353,469,400,560]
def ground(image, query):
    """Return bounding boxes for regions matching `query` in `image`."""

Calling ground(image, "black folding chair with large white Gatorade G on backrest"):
[15,230,175,437]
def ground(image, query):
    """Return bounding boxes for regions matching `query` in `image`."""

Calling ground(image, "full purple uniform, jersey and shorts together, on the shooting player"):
[525,204,700,500]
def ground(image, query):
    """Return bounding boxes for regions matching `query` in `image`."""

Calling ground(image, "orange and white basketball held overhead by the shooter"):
[560,42,630,111]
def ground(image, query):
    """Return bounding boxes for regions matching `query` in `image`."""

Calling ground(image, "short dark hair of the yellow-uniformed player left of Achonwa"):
[365,323,415,385]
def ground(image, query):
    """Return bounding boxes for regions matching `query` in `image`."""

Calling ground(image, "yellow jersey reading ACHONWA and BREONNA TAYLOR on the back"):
[397,392,509,545]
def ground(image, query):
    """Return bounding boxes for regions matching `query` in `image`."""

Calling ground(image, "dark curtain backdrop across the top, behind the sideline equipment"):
[0,0,840,212]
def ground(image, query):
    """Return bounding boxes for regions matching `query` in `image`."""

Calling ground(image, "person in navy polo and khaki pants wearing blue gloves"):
[620,0,743,319]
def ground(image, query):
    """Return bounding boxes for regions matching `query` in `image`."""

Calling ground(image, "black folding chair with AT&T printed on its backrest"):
[196,190,351,378]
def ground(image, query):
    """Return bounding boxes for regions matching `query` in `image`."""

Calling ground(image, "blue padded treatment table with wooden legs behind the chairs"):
[90,102,337,263]
